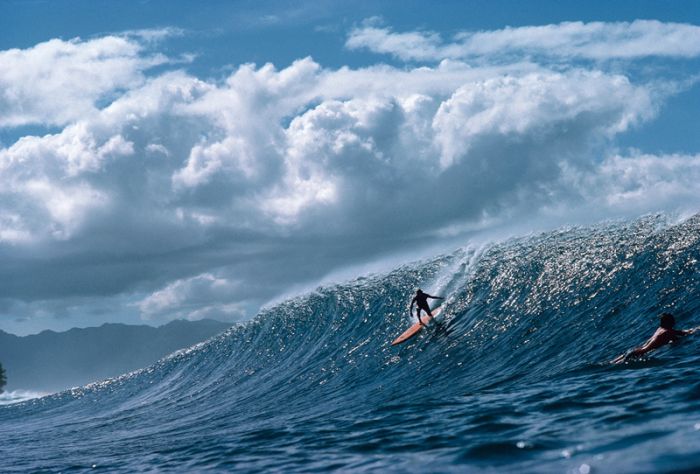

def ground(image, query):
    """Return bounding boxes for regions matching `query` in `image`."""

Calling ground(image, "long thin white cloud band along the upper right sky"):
[346,20,700,62]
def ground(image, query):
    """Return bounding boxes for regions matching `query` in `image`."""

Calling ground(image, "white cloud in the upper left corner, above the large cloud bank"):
[0,32,166,127]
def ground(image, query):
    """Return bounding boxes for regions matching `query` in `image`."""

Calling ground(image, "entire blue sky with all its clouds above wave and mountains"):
[0,0,700,334]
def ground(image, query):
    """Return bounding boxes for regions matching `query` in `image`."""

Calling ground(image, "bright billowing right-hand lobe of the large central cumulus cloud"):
[433,70,654,168]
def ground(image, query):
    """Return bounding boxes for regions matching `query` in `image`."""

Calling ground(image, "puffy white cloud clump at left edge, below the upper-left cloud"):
[0,123,133,241]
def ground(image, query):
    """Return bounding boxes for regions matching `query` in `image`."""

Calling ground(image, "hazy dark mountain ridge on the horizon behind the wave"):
[0,319,231,392]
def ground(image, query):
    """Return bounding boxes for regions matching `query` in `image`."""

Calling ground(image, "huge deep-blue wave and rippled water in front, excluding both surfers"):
[0,216,700,472]
